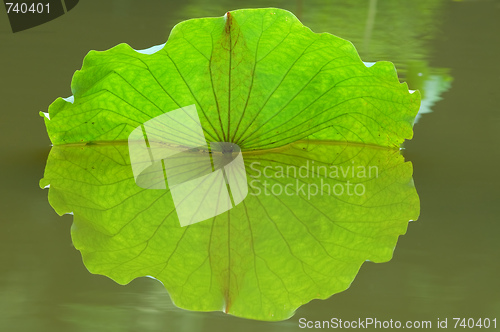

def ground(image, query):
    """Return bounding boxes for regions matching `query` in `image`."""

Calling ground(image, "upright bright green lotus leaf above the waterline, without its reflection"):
[41,9,420,151]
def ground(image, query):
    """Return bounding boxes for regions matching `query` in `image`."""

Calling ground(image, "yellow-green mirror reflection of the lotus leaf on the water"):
[40,141,419,320]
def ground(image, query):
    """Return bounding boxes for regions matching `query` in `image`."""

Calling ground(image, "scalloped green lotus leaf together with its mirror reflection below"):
[40,9,420,320]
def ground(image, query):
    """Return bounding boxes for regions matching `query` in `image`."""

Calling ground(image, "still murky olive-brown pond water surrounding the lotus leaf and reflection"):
[0,0,500,331]
